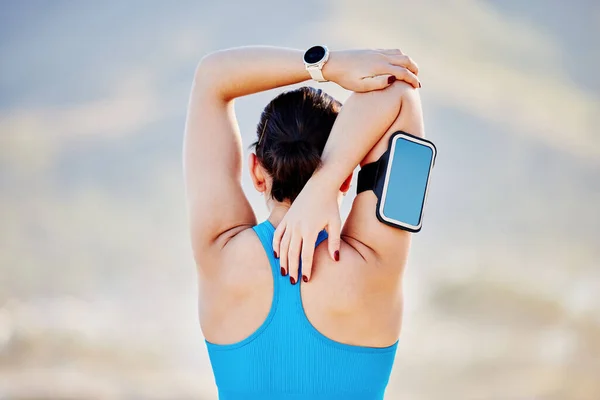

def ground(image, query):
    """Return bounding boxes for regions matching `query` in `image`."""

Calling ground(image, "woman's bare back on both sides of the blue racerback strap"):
[199,220,402,347]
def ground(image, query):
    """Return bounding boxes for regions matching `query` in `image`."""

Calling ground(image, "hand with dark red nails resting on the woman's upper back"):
[273,179,342,284]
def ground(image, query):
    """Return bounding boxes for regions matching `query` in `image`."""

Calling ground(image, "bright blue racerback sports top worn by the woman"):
[206,221,398,400]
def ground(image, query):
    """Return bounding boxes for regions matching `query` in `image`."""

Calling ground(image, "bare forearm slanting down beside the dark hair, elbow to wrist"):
[311,82,414,189]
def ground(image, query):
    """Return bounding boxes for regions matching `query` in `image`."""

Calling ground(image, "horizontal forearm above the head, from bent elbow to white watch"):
[194,46,310,101]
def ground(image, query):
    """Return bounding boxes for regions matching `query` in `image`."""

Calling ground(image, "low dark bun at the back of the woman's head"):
[269,139,321,202]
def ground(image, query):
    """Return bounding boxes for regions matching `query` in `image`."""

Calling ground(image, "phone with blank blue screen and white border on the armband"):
[379,135,435,230]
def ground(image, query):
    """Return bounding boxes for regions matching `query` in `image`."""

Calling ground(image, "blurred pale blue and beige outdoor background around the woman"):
[0,0,600,400]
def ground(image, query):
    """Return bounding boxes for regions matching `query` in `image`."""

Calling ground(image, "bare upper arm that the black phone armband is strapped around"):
[342,82,424,266]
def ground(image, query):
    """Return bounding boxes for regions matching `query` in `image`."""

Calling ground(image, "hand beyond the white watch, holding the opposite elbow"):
[323,49,421,92]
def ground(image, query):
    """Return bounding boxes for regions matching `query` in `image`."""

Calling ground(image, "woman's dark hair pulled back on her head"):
[253,87,341,201]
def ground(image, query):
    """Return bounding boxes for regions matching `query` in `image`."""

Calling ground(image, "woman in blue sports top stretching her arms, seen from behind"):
[184,47,423,400]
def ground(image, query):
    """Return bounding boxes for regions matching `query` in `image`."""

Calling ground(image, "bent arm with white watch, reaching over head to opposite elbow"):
[184,46,419,267]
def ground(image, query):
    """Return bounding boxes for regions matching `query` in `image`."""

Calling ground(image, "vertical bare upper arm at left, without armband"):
[183,67,256,263]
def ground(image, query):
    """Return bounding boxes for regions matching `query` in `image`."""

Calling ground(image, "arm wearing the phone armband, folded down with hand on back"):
[274,82,423,279]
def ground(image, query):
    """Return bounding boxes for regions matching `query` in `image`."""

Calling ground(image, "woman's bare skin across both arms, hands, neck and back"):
[184,48,423,347]
